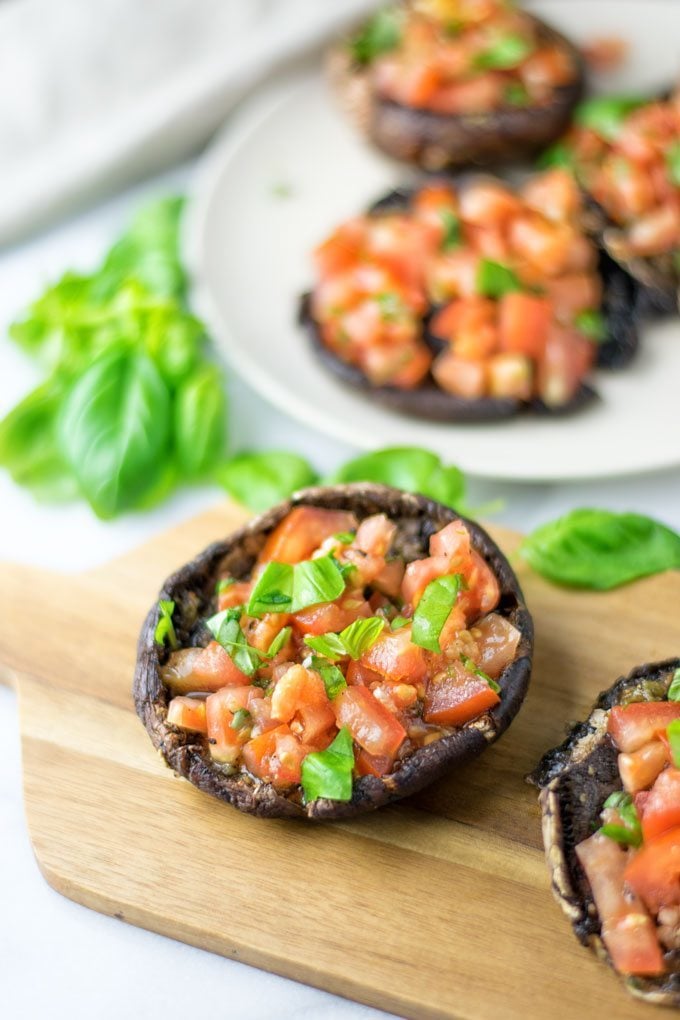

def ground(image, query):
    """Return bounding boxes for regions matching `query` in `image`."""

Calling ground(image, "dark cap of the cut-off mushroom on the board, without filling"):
[527,659,680,1007]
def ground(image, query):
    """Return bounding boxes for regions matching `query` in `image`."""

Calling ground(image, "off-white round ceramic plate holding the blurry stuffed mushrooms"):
[187,0,680,480]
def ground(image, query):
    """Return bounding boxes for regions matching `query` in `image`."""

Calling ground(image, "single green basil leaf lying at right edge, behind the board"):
[520,509,680,591]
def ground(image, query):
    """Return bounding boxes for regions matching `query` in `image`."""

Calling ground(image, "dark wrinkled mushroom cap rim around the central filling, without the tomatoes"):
[134,483,533,820]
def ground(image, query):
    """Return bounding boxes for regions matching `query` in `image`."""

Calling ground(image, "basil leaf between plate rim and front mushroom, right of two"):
[329,447,465,507]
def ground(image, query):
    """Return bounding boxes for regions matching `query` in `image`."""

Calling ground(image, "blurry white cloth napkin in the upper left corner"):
[0,0,375,244]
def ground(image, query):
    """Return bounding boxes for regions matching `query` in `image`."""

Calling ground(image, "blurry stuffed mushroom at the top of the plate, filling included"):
[328,0,584,171]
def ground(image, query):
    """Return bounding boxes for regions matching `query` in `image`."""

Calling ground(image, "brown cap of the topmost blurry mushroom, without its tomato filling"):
[327,12,585,170]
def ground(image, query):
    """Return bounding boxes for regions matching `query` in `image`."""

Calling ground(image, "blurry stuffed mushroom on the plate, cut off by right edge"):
[541,92,680,314]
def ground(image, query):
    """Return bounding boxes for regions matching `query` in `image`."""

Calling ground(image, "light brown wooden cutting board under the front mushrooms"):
[0,506,680,1020]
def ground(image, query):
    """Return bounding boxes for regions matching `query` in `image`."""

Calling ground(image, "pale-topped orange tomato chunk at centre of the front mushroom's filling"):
[271,665,335,747]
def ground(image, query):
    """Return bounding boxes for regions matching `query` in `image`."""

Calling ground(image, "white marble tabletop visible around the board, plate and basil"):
[0,167,680,1020]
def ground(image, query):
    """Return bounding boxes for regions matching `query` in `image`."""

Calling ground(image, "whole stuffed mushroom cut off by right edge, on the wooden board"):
[529,659,680,1007]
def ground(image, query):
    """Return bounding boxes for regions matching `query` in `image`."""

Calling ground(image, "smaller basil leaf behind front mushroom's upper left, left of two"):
[215,452,318,510]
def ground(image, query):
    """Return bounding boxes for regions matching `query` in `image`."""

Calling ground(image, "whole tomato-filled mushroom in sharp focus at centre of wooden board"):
[135,485,533,819]
